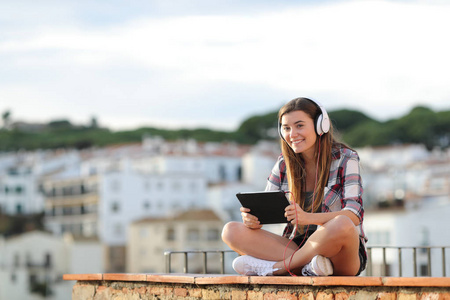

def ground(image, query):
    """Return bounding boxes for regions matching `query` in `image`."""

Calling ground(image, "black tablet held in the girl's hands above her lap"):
[236,191,290,224]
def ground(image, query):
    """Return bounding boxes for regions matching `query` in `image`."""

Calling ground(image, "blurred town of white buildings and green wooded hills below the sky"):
[0,107,450,299]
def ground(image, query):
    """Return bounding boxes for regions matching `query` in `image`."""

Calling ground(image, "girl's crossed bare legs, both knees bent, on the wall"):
[222,215,360,276]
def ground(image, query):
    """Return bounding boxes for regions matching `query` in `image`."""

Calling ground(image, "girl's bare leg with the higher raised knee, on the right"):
[274,215,360,276]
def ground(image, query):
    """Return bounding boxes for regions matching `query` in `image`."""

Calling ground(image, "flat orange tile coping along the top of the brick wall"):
[63,273,450,287]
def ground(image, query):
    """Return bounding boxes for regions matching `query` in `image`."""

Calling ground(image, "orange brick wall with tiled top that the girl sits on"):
[63,274,450,300]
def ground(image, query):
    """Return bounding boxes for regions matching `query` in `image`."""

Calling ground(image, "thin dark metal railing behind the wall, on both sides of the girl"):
[164,246,450,277]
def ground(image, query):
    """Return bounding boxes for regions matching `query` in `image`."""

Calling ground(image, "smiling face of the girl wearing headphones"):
[281,110,317,159]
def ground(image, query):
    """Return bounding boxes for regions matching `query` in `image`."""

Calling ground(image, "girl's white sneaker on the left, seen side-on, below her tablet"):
[233,255,279,276]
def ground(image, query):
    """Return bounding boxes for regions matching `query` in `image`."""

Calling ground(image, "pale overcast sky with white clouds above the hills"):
[0,0,450,130]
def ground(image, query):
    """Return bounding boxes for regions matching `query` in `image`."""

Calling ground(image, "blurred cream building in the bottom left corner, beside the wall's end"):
[0,231,103,300]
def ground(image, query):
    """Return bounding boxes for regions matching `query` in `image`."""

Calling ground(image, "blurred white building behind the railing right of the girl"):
[364,198,450,277]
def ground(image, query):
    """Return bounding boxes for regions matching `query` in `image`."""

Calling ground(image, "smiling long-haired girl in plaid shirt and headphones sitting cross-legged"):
[222,98,367,276]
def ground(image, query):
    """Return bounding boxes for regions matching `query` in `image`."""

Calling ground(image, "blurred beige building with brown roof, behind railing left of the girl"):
[127,210,225,273]
